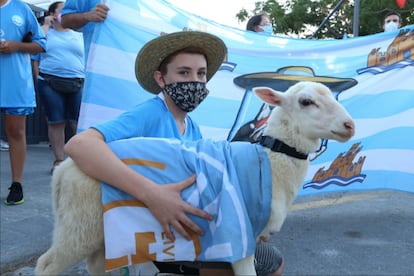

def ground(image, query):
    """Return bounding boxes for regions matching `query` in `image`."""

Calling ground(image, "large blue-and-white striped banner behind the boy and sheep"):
[84,0,414,195]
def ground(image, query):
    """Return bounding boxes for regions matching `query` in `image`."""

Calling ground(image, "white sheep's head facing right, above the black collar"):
[254,82,355,142]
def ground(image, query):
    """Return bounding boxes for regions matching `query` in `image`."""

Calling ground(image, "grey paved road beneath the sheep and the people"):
[0,144,414,276]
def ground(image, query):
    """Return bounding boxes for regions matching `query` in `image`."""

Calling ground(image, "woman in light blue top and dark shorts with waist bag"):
[32,1,85,175]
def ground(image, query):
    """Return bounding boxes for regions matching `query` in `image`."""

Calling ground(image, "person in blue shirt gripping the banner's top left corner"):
[62,0,109,60]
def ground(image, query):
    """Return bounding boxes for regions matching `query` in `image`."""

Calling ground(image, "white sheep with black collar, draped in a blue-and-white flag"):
[35,82,354,275]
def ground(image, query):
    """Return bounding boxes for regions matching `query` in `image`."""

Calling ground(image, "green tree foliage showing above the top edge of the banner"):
[236,0,414,39]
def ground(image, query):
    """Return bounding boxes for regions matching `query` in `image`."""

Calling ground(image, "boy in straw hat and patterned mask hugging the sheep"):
[65,31,282,275]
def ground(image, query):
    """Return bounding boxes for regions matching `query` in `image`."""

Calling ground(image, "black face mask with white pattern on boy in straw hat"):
[162,81,209,112]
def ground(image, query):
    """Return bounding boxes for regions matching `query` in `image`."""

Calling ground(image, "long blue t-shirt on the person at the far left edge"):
[0,0,46,107]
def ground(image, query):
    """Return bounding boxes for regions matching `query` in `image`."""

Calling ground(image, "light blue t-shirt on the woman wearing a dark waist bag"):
[39,28,85,78]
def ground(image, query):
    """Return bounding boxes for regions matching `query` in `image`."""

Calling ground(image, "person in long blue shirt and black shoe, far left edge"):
[0,0,46,205]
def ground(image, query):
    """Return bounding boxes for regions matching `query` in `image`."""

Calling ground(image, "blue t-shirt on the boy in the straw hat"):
[93,96,202,143]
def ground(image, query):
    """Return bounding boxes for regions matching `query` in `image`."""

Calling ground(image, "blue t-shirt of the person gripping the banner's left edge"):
[62,0,101,60]
